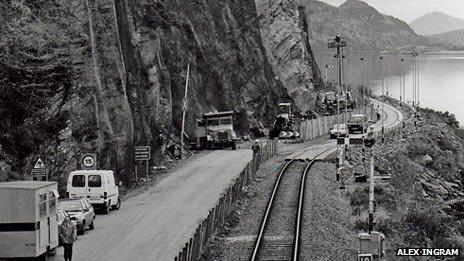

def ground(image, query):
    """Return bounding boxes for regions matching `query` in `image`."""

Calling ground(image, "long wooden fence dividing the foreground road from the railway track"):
[174,141,277,261]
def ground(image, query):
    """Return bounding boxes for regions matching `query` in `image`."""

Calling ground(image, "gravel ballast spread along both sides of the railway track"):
[204,137,357,261]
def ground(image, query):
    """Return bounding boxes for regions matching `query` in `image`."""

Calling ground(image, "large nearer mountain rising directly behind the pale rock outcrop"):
[299,0,425,50]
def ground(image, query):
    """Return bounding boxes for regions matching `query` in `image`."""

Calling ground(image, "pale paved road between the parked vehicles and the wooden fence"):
[51,149,251,261]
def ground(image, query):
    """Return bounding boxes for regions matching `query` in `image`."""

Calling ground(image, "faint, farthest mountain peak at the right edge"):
[409,12,464,35]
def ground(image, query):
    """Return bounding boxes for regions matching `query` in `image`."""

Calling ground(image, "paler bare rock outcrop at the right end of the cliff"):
[255,0,321,112]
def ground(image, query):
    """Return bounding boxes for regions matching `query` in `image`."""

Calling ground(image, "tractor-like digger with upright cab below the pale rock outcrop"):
[269,102,299,139]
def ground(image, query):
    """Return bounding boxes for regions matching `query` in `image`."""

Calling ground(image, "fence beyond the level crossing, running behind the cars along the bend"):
[300,104,376,141]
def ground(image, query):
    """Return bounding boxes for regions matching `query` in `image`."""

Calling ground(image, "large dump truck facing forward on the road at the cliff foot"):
[190,111,237,150]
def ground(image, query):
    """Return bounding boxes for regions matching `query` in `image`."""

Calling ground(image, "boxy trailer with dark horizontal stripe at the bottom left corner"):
[0,181,58,260]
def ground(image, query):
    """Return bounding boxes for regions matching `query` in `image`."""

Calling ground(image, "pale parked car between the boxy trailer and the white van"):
[58,198,95,235]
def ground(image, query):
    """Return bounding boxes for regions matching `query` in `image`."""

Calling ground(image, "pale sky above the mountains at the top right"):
[319,0,464,23]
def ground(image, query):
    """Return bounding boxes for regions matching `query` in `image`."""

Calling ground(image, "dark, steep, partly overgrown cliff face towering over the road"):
[0,0,290,187]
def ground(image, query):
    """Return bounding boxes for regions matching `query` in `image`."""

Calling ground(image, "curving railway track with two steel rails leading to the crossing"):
[249,148,332,261]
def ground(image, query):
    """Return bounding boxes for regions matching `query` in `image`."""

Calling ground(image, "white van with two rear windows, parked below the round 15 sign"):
[66,170,121,214]
